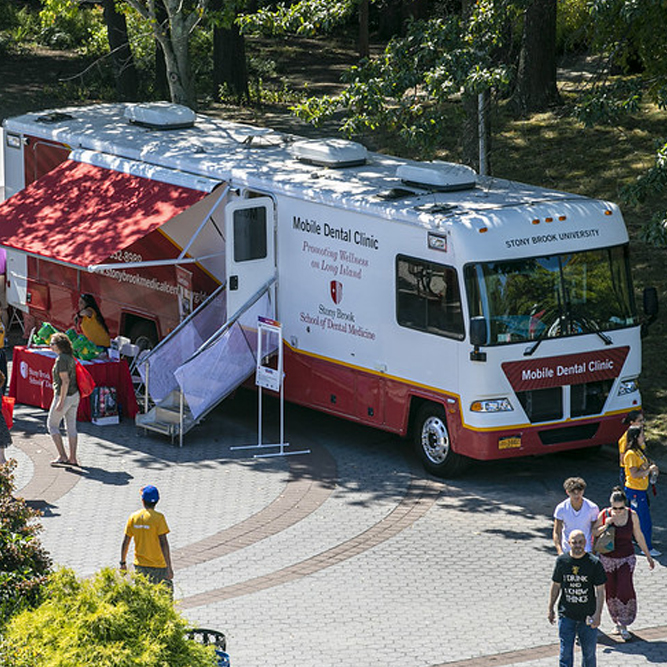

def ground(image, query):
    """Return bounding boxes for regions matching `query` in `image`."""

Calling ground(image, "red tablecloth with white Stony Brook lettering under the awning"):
[9,346,138,421]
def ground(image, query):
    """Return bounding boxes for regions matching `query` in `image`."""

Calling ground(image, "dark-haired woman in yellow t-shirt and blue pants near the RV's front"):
[623,426,660,557]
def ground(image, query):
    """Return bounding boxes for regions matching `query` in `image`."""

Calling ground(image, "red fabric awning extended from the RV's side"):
[0,160,207,267]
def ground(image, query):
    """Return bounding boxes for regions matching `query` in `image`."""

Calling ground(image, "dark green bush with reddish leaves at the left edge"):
[0,461,51,624]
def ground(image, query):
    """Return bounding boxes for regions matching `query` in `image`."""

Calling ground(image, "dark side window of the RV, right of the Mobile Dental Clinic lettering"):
[396,255,464,340]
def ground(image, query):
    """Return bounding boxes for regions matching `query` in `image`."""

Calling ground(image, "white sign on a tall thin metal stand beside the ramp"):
[230,316,310,459]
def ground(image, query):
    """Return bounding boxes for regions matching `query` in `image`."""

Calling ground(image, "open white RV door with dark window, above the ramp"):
[225,197,276,317]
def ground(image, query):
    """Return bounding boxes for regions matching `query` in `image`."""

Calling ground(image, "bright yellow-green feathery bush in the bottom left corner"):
[0,568,216,667]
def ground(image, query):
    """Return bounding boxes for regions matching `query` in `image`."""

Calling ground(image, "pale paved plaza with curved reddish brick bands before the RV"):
[8,392,667,667]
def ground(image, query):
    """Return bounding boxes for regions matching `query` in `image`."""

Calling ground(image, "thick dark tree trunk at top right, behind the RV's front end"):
[513,0,560,115]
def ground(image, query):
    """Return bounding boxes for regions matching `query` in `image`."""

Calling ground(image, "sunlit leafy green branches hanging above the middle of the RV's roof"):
[295,0,517,161]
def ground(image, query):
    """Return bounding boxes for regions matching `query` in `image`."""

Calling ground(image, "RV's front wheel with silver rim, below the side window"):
[414,403,467,477]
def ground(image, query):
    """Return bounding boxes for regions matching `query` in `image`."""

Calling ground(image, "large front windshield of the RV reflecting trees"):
[465,246,638,345]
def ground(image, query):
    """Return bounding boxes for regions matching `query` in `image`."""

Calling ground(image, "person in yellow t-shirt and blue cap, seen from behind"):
[120,485,174,593]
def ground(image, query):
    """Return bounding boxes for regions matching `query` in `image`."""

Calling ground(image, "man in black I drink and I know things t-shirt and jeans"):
[548,530,607,667]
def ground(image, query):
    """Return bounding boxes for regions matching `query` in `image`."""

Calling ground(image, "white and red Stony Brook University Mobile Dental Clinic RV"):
[0,103,657,476]
